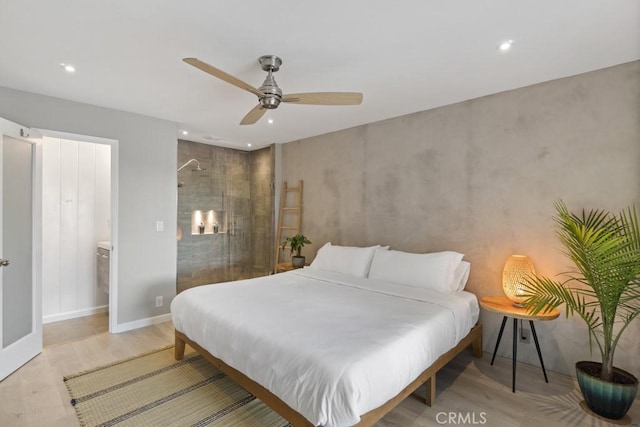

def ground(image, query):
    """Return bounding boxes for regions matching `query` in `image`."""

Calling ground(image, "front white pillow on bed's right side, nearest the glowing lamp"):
[369,251,463,293]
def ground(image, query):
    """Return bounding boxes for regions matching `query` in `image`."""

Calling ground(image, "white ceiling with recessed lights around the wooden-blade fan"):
[0,0,640,149]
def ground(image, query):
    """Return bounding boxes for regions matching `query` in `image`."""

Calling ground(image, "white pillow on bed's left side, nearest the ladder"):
[309,242,380,277]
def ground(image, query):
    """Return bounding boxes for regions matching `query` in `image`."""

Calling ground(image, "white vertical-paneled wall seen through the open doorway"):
[42,137,111,323]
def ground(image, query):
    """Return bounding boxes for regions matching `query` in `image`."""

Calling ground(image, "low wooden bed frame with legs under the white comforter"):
[175,322,482,427]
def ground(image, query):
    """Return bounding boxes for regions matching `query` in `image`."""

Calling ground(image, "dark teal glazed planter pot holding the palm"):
[576,361,638,420]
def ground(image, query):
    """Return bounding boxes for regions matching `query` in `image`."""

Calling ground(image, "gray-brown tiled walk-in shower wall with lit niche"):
[176,140,274,292]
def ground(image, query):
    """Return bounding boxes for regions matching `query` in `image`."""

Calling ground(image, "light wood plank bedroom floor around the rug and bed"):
[0,322,640,427]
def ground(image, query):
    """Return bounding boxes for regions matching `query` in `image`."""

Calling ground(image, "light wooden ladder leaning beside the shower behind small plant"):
[274,181,302,273]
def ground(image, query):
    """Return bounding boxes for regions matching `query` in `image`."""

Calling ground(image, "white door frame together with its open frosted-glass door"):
[0,118,118,380]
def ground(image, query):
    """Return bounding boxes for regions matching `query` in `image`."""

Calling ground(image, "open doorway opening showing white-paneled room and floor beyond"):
[38,130,117,345]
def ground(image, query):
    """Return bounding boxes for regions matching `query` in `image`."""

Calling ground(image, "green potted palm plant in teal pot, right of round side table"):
[525,201,640,419]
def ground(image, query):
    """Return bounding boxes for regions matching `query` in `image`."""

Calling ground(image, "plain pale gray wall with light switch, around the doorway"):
[0,87,177,330]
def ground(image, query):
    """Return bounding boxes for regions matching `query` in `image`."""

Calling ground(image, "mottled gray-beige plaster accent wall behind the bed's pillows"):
[282,62,640,381]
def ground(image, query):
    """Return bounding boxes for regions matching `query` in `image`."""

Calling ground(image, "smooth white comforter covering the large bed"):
[171,268,477,427]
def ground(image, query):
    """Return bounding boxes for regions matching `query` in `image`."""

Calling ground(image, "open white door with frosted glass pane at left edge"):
[0,118,42,380]
